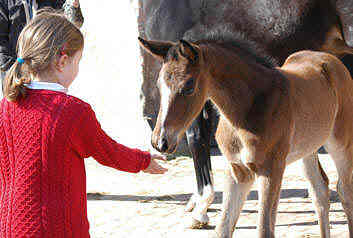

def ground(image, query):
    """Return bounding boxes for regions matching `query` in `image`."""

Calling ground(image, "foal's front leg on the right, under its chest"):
[257,158,286,238]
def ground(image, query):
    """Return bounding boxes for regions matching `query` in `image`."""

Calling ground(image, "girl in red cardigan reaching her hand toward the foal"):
[0,12,166,238]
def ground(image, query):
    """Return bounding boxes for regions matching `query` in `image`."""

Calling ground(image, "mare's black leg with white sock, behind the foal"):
[185,102,214,228]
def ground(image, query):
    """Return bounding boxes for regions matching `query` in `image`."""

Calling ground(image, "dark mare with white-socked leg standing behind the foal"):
[138,0,353,226]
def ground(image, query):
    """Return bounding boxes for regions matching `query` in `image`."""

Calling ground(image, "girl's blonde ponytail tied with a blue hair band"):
[4,58,30,102]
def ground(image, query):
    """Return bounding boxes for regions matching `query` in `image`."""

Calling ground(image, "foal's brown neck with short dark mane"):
[201,44,284,127]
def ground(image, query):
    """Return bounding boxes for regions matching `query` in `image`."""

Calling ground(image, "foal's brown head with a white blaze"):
[139,38,207,153]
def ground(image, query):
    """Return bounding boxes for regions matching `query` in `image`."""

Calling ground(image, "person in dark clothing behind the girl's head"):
[0,0,83,93]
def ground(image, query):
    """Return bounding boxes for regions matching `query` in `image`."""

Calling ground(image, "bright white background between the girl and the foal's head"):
[69,0,151,149]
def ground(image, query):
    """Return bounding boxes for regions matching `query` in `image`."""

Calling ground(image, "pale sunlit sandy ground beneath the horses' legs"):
[86,155,348,238]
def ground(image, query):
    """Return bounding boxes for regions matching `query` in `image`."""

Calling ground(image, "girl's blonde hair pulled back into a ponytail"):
[4,9,84,101]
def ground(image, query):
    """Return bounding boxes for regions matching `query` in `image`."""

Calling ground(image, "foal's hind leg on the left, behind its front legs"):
[302,153,330,238]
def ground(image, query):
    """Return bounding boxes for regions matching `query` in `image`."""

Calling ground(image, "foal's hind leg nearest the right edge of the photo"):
[327,145,353,238]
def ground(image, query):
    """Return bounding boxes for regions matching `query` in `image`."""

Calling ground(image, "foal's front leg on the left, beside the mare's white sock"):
[213,163,255,238]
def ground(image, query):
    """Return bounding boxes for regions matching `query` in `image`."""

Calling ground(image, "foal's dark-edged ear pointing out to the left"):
[138,37,174,61]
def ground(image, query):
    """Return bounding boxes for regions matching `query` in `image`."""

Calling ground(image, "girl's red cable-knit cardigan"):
[0,90,151,238]
